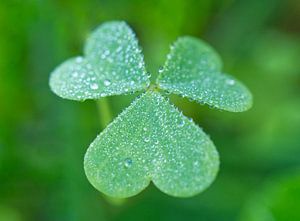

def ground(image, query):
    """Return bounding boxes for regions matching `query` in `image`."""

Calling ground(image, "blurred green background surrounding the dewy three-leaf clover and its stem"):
[0,0,300,221]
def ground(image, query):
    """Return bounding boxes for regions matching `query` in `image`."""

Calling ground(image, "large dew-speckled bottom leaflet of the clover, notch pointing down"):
[84,91,219,198]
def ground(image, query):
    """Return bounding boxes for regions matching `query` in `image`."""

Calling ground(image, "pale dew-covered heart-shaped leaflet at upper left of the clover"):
[50,22,150,100]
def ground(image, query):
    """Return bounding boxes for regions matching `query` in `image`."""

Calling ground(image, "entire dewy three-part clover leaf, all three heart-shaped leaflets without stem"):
[50,21,252,198]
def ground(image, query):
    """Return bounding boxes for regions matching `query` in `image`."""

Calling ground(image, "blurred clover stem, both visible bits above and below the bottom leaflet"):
[96,97,125,206]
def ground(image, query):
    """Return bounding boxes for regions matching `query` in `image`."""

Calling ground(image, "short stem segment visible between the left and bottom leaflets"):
[96,97,112,130]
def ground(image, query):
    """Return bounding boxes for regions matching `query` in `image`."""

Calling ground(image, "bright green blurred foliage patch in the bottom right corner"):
[241,170,300,221]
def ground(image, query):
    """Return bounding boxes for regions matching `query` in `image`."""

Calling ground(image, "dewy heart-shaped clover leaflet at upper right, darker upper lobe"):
[157,37,252,112]
